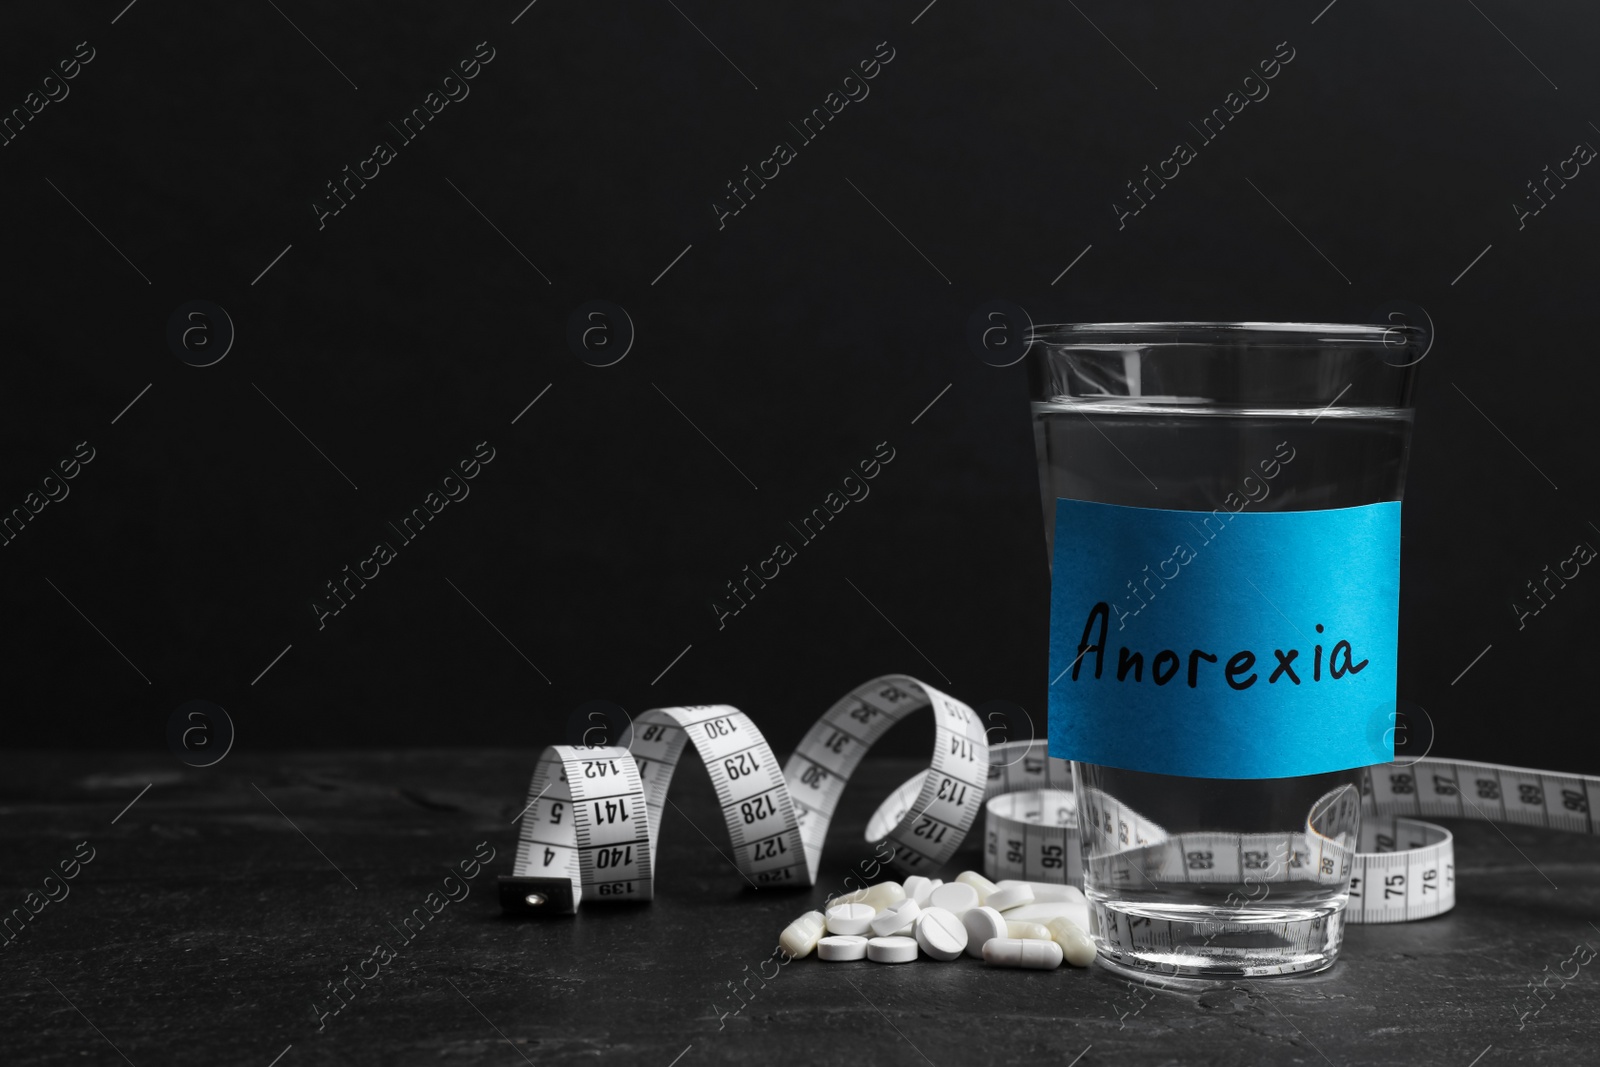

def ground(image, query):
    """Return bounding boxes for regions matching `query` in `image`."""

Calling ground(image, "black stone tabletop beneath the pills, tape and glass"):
[0,750,1600,1067]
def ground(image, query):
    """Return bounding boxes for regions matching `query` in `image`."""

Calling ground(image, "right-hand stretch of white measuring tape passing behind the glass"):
[972,742,1600,923]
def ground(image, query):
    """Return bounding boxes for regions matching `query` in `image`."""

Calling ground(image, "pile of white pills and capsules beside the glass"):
[778,870,1094,971]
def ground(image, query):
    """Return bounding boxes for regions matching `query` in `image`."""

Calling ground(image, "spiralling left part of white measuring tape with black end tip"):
[499,675,989,913]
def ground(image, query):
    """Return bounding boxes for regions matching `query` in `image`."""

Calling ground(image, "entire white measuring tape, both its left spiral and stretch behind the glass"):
[499,675,1600,923]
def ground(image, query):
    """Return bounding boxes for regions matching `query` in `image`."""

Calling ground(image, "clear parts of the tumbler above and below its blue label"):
[1029,323,1427,977]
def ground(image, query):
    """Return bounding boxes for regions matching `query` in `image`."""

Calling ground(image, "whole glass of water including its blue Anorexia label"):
[1029,323,1429,977]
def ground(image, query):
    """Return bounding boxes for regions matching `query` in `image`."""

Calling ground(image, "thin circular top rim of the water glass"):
[1029,322,1426,349]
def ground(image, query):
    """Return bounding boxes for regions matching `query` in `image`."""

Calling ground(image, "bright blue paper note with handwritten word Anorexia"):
[1050,499,1400,777]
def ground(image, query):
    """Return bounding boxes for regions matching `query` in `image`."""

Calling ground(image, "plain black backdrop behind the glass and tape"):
[0,0,1600,773]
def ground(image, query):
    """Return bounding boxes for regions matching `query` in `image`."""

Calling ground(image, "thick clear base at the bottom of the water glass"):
[1090,897,1344,981]
